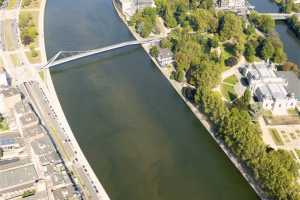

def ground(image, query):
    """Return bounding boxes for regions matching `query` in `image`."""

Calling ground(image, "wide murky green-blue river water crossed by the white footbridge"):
[45,0,294,200]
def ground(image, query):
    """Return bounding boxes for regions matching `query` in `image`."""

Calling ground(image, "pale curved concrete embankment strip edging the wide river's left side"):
[39,0,110,200]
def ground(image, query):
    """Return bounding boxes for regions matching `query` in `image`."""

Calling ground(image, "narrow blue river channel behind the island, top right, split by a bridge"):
[249,0,300,68]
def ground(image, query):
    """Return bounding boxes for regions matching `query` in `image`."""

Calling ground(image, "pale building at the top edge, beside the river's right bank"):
[116,0,155,18]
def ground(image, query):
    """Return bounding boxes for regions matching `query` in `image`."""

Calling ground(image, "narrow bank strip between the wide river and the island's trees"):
[113,0,268,200]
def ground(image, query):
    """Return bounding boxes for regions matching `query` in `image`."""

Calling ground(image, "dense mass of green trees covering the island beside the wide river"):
[114,0,300,200]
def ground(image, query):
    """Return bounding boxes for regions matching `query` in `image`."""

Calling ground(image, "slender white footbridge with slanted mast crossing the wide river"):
[42,38,160,68]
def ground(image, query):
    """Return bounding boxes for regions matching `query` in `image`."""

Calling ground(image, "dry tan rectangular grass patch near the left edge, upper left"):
[3,20,18,51]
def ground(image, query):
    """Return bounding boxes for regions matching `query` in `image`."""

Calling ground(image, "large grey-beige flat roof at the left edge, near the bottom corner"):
[0,164,38,190]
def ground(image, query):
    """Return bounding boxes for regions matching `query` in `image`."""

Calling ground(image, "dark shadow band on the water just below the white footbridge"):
[50,45,142,74]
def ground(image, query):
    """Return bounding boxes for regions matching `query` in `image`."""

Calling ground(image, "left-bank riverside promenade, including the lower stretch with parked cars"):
[36,0,110,200]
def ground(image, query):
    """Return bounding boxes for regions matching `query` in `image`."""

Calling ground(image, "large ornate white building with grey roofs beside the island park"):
[242,62,297,115]
